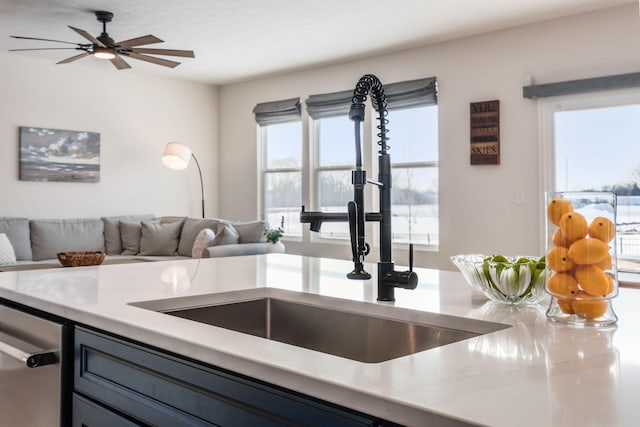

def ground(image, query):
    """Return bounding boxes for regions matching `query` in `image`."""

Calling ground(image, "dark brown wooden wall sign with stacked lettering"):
[470,100,500,165]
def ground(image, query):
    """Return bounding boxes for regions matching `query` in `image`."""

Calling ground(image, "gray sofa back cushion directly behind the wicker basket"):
[29,218,104,261]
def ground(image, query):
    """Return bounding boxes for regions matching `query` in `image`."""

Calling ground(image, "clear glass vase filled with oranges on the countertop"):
[545,192,618,326]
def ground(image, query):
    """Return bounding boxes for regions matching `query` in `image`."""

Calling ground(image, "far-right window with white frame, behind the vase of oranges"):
[542,90,640,273]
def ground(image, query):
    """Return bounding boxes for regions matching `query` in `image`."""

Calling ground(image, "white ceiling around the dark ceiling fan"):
[0,0,636,84]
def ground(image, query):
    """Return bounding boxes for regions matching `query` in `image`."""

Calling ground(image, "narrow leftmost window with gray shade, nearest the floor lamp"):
[254,98,302,238]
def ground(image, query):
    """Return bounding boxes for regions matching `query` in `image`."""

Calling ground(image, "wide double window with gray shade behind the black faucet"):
[306,78,438,246]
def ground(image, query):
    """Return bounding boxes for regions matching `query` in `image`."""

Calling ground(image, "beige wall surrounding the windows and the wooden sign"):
[220,5,640,269]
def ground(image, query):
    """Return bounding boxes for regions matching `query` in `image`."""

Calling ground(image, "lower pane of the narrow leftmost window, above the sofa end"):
[264,172,302,236]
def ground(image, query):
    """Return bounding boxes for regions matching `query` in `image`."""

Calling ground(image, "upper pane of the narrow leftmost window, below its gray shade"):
[265,122,302,169]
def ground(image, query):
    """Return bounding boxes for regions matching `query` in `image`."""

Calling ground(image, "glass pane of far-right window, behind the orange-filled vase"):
[554,105,640,272]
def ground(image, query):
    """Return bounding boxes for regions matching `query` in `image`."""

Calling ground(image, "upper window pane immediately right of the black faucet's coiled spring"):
[382,105,438,163]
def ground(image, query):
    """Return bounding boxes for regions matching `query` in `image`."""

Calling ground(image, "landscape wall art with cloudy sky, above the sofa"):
[20,127,100,182]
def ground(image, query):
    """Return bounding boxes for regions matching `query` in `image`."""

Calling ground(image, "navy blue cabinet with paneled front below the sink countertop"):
[73,327,393,427]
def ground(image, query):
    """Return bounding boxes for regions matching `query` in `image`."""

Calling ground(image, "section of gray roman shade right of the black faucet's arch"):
[382,77,438,110]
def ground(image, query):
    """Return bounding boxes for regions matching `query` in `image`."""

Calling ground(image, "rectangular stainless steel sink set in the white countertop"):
[133,289,509,363]
